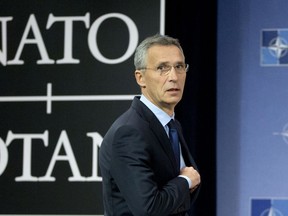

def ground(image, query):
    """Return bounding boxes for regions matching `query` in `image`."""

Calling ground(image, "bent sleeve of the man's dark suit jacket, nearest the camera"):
[111,126,190,216]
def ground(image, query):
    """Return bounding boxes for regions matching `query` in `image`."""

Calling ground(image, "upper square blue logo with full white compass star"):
[261,29,288,66]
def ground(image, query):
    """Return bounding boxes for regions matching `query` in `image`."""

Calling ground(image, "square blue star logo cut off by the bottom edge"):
[251,198,288,216]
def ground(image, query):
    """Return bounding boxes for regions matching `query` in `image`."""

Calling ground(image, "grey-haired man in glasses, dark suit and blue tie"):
[99,34,200,216]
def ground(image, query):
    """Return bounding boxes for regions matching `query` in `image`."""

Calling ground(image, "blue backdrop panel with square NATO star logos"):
[217,0,288,216]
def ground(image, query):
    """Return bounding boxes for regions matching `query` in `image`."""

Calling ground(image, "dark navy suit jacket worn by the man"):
[99,97,199,216]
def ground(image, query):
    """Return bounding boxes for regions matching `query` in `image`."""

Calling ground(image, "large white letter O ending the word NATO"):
[88,13,139,64]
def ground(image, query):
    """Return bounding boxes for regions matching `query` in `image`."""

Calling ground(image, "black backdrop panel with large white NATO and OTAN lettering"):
[0,0,165,215]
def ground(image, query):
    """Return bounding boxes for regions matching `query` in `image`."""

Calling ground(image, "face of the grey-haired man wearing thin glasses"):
[136,45,186,114]
